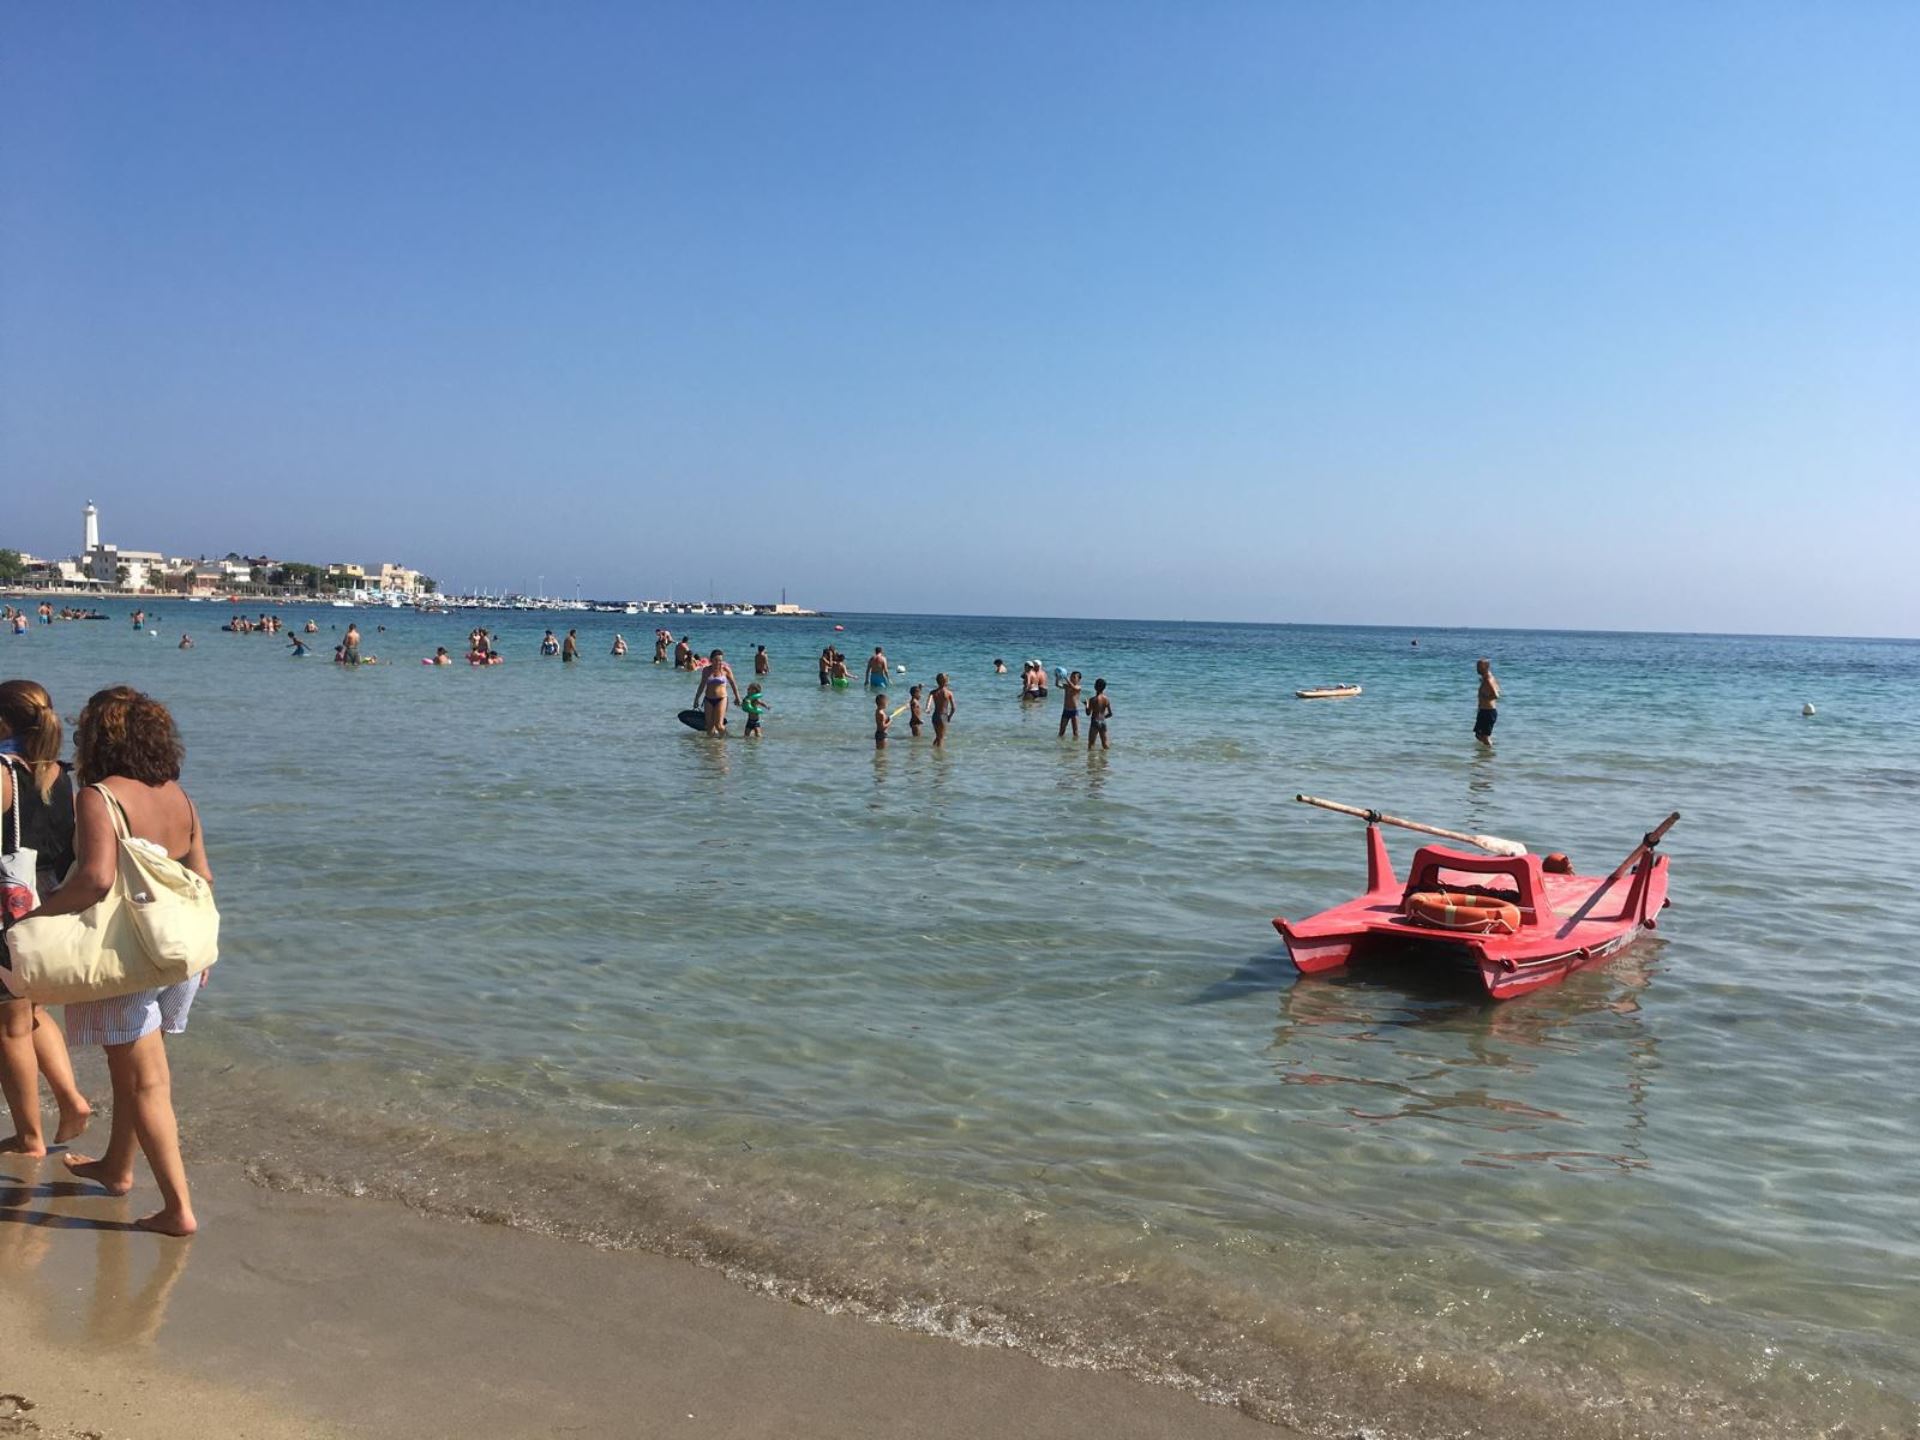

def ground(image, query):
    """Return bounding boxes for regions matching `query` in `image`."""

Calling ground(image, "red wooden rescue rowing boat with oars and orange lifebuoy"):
[1273,795,1680,1000]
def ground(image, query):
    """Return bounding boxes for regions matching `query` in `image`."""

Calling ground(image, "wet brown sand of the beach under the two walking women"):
[0,1156,1284,1440]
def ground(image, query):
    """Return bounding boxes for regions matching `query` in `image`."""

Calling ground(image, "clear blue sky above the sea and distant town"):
[0,0,1920,636]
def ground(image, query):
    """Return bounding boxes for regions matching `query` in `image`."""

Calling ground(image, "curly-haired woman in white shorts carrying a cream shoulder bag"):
[36,685,213,1235]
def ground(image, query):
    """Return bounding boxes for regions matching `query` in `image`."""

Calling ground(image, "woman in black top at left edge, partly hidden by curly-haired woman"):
[0,680,92,1156]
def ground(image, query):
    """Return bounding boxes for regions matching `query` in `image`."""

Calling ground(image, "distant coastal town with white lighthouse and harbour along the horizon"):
[0,501,820,616]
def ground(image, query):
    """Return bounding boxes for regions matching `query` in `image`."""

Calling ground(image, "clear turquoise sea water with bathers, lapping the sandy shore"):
[0,603,1920,1436]
